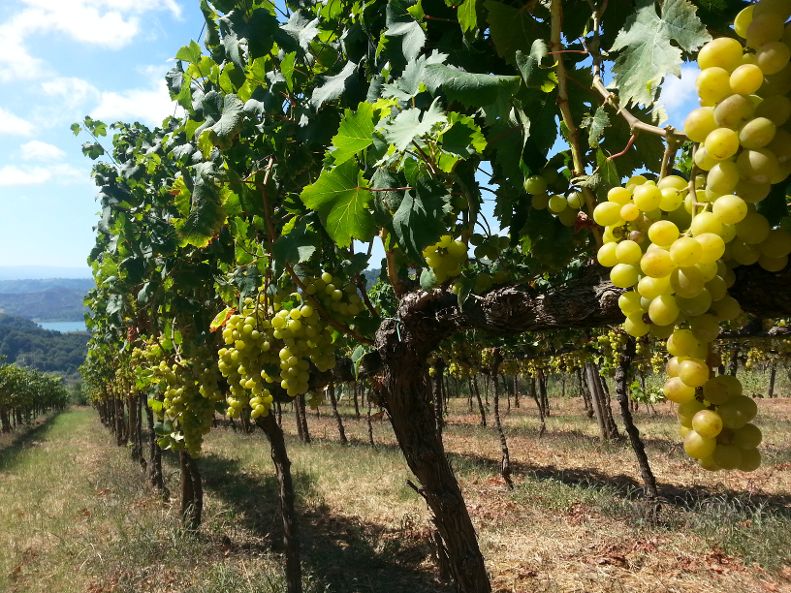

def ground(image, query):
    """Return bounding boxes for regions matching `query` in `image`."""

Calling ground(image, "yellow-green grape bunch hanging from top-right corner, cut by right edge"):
[684,0,791,272]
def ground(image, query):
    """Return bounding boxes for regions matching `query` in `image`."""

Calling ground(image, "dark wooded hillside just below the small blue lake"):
[0,315,88,375]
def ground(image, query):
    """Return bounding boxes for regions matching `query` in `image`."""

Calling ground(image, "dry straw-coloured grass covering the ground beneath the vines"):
[0,380,791,593]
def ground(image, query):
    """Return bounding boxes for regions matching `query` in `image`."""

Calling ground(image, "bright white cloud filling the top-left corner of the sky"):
[0,0,182,82]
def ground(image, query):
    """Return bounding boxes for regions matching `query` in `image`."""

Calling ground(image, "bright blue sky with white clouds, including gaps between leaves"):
[0,0,696,271]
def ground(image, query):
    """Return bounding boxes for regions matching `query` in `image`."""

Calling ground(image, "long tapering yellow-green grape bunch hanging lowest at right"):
[594,176,760,471]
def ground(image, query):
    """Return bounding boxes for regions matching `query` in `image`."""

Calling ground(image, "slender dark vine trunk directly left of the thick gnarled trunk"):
[257,414,302,593]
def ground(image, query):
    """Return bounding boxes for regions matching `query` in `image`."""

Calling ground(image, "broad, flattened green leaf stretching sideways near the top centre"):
[425,64,519,107]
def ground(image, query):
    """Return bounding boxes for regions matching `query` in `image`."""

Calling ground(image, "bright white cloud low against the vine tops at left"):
[91,80,175,126]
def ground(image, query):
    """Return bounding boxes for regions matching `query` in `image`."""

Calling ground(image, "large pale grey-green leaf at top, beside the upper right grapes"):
[610,0,711,105]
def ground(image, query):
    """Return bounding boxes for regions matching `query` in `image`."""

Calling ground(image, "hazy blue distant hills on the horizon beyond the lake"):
[0,278,93,321]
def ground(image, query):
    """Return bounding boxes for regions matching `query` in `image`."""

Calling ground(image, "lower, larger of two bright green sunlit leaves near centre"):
[300,161,376,247]
